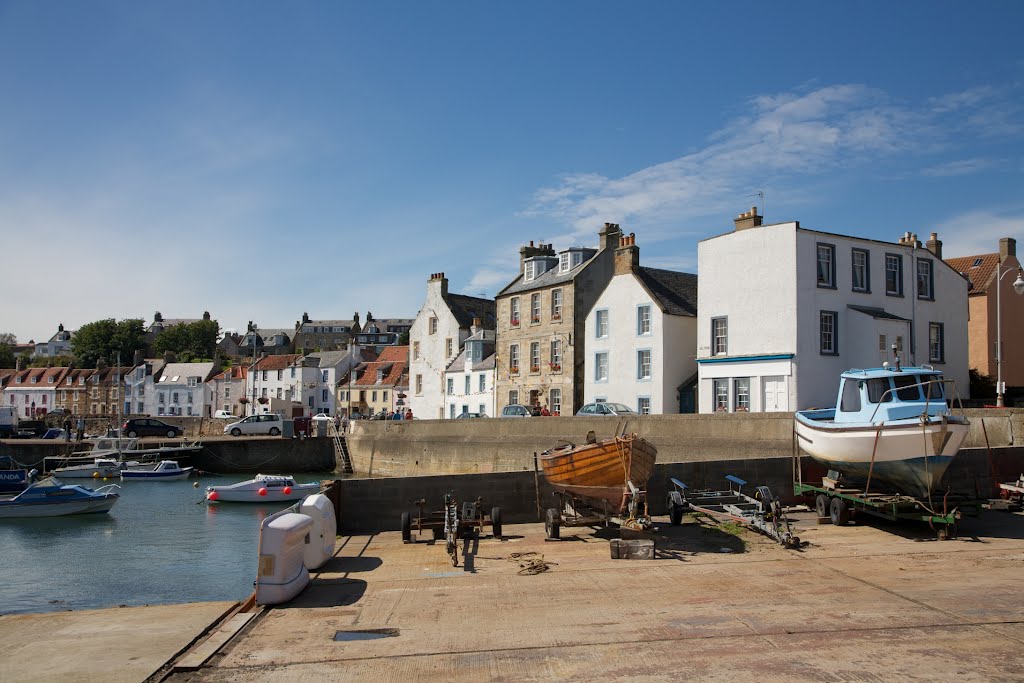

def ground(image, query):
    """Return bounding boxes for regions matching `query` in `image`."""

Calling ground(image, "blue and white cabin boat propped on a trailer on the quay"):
[796,360,970,498]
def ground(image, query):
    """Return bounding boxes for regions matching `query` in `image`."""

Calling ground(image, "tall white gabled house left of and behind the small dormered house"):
[409,272,495,419]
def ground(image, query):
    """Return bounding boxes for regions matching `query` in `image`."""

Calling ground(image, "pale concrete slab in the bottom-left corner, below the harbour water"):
[0,602,238,683]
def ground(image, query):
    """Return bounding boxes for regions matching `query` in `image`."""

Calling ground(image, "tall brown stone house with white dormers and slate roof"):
[495,223,623,415]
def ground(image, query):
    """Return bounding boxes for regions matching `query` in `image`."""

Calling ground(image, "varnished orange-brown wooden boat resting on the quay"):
[540,434,657,512]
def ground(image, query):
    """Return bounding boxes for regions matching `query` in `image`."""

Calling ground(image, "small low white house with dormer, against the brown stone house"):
[444,326,495,418]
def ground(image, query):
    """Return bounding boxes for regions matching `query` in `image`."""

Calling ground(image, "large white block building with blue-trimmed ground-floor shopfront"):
[697,208,970,413]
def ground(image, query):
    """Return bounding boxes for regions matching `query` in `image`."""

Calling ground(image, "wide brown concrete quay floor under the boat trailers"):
[167,511,1024,683]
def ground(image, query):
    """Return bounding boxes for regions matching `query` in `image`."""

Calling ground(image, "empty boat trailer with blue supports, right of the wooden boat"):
[668,474,801,549]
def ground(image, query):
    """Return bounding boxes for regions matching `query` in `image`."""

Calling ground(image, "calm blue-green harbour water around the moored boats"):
[0,473,335,614]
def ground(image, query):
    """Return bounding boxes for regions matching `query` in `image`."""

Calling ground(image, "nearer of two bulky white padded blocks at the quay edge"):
[256,511,313,605]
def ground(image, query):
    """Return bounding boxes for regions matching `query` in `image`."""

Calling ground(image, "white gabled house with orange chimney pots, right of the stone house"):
[584,234,697,415]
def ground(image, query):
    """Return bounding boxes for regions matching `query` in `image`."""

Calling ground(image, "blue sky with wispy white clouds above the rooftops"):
[0,0,1024,341]
